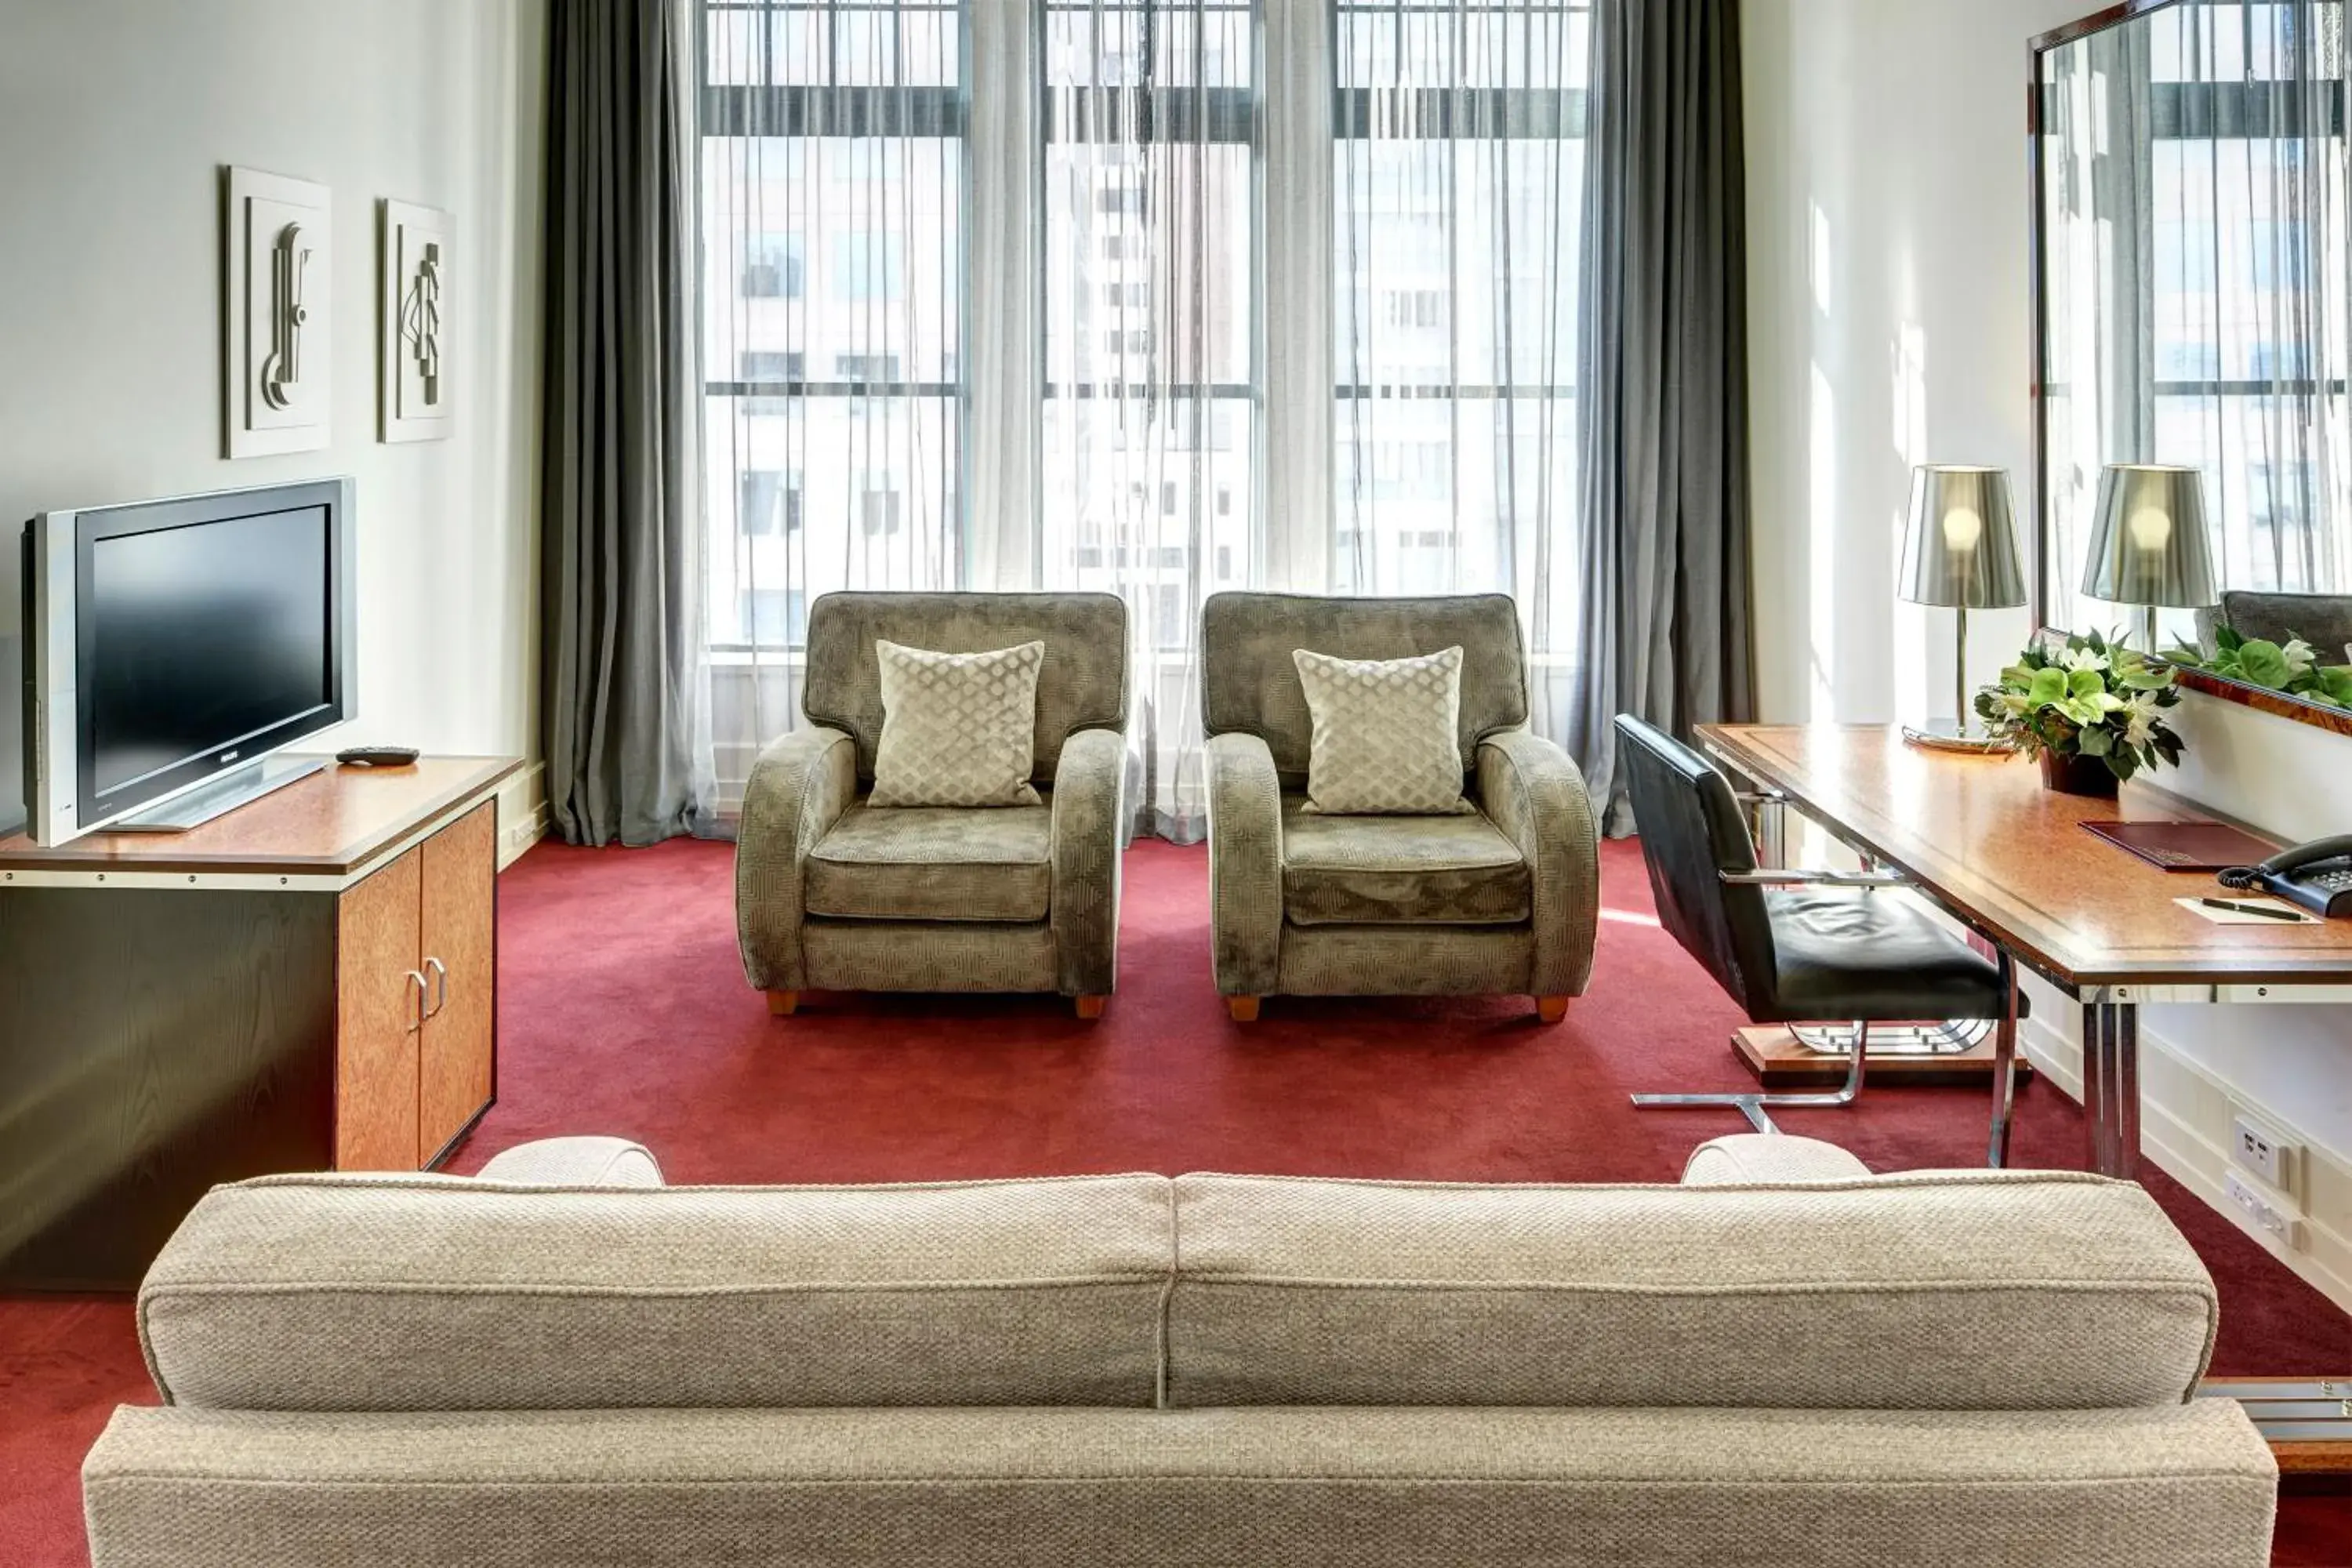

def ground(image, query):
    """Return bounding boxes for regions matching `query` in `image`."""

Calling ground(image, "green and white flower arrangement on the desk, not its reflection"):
[1976,633,2180,792]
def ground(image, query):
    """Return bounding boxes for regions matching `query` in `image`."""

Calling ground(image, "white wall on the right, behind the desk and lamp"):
[1740,0,2352,1307]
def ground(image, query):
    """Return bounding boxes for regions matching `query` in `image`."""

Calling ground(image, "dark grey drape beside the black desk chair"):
[1564,0,1755,834]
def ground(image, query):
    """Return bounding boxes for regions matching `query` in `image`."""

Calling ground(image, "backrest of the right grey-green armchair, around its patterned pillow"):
[1200,593,1526,789]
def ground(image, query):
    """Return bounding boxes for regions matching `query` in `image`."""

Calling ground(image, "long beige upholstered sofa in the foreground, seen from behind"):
[82,1138,2277,1568]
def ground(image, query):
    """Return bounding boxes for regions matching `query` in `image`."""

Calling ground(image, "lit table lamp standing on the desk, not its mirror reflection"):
[1903,463,2025,753]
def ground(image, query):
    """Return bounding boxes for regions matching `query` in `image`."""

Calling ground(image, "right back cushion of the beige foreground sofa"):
[1167,1173,2216,1410]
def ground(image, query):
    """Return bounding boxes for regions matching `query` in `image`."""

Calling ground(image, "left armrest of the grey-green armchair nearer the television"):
[736,727,858,989]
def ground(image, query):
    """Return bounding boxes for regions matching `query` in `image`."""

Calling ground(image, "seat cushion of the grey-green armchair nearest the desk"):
[1282,794,1534,926]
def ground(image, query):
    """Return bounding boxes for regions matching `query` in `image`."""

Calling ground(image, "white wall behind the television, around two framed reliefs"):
[0,0,546,860]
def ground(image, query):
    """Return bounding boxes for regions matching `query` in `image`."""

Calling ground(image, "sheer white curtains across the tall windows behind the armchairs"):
[701,0,1585,839]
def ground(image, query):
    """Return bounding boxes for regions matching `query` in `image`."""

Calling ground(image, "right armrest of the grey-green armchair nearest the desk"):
[1477,729,1602,996]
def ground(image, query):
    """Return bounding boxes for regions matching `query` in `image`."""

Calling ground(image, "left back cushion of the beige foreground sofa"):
[139,1175,1174,1410]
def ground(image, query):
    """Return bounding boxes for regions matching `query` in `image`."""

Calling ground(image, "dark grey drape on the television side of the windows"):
[541,0,708,844]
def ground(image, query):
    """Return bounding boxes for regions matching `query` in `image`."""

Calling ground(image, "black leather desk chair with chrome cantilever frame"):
[1616,715,2023,1166]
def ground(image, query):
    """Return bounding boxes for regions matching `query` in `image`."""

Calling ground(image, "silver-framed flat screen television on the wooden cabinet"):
[24,480,355,844]
